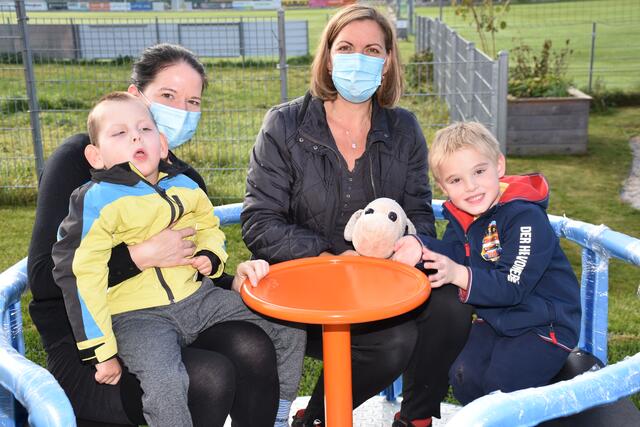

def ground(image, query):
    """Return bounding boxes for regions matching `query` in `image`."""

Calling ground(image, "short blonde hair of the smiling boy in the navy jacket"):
[429,122,502,181]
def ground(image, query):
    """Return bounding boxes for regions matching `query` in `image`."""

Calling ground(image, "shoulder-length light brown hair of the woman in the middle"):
[310,4,403,108]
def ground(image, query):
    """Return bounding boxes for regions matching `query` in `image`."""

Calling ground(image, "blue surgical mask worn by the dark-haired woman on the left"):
[138,89,201,150]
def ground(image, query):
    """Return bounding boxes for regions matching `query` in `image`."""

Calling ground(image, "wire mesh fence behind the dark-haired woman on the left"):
[0,1,308,203]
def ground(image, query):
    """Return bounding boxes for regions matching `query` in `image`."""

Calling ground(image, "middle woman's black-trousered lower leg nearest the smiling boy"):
[401,285,473,420]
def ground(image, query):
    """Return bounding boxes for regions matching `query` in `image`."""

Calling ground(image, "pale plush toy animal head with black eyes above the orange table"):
[344,197,416,258]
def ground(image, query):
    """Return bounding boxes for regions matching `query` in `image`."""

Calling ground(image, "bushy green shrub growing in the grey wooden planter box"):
[509,40,573,98]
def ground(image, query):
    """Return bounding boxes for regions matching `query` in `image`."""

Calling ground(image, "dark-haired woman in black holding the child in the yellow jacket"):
[28,44,279,427]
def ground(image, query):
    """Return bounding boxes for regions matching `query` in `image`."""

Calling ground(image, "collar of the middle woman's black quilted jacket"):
[299,95,392,146]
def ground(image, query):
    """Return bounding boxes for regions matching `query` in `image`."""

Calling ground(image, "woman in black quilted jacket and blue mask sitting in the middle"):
[241,5,471,426]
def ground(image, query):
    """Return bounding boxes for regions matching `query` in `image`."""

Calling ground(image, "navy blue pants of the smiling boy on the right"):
[449,321,569,405]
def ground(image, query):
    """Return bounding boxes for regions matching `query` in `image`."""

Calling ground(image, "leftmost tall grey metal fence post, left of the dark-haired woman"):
[15,0,44,178]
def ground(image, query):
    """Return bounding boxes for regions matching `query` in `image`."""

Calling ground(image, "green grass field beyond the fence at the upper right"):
[416,0,640,91]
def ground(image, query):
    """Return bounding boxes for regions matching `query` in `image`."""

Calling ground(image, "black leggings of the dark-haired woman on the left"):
[47,322,279,427]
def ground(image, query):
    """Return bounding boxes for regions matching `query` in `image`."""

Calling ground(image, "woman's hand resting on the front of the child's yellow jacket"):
[128,227,196,270]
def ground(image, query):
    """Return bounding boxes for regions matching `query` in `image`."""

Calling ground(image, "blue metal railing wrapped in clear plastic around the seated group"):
[0,201,640,427]
